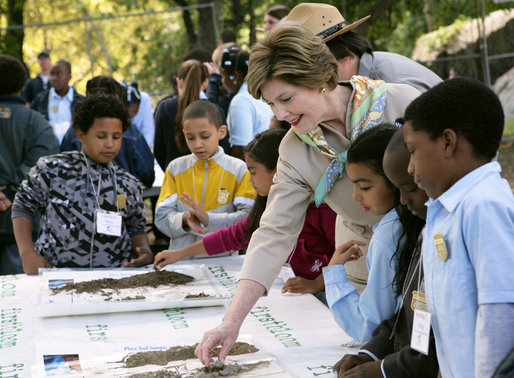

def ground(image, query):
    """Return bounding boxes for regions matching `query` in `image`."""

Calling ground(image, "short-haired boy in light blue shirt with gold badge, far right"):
[404,78,514,378]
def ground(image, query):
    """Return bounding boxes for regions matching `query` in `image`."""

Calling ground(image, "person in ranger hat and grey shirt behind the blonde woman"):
[284,3,442,92]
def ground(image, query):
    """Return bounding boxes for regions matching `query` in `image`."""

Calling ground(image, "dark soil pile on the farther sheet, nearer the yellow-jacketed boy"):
[52,270,194,294]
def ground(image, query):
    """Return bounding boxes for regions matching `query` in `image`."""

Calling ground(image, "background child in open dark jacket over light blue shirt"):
[31,60,84,144]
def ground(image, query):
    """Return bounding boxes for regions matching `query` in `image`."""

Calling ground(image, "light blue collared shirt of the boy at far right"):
[422,162,514,377]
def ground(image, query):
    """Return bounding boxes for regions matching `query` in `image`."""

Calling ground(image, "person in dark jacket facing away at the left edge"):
[0,55,59,275]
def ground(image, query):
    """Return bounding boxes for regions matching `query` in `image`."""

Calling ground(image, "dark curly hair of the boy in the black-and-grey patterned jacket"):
[72,92,131,134]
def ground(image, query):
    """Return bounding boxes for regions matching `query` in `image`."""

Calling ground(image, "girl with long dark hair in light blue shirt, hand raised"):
[323,124,405,342]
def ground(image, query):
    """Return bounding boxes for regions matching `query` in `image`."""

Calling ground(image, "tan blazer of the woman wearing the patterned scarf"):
[240,82,420,290]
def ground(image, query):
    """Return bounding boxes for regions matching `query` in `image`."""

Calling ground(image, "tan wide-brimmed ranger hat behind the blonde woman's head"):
[284,3,371,42]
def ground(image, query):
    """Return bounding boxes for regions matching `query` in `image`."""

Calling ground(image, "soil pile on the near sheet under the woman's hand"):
[121,342,259,368]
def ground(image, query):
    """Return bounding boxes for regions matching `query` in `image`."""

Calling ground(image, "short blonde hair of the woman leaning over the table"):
[247,22,338,98]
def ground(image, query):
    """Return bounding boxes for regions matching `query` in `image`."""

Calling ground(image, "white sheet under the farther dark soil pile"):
[39,265,230,317]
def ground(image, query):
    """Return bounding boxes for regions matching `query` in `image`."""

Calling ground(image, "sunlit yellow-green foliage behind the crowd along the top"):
[0,0,508,99]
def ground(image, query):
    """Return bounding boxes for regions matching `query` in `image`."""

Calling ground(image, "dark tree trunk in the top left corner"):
[1,0,26,65]
